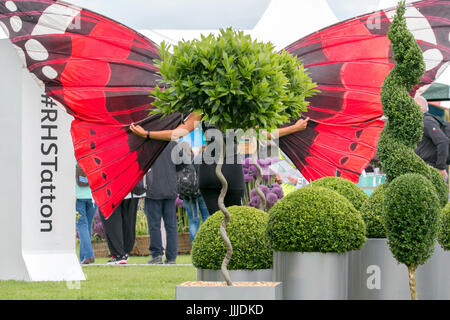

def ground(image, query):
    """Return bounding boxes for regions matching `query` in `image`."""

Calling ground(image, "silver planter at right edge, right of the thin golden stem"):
[416,243,450,300]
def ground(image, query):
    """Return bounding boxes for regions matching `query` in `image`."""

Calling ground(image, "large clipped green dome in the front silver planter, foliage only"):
[267,187,366,253]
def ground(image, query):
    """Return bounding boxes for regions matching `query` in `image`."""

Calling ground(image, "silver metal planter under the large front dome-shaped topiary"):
[273,251,348,300]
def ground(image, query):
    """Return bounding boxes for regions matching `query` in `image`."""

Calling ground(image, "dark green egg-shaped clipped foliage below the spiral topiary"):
[384,173,440,268]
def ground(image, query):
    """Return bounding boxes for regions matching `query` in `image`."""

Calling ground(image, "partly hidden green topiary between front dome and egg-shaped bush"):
[359,183,387,238]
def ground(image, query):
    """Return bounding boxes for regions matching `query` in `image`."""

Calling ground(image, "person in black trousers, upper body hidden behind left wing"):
[100,181,145,264]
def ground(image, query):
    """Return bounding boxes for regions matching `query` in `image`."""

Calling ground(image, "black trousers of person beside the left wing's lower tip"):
[100,198,139,256]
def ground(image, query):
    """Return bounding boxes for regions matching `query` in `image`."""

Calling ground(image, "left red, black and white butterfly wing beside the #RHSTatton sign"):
[0,0,180,217]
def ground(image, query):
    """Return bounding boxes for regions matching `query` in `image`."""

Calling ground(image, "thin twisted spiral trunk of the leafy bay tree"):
[216,137,233,286]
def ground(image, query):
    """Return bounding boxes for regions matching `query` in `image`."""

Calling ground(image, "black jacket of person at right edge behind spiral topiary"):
[415,113,449,170]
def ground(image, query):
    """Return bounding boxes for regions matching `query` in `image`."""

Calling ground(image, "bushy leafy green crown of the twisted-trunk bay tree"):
[152,28,317,130]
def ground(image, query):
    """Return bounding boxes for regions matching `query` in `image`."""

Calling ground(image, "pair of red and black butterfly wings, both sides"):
[0,0,450,218]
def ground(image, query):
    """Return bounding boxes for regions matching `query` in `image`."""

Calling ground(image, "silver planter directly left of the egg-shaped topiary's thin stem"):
[348,239,411,300]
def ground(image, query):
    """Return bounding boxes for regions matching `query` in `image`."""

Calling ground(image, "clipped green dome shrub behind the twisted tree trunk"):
[192,206,273,270]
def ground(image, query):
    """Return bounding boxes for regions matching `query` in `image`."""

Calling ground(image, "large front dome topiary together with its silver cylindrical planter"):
[267,186,366,300]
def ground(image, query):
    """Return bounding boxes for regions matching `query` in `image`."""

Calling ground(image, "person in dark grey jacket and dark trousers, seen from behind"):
[144,139,178,264]
